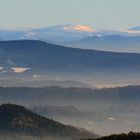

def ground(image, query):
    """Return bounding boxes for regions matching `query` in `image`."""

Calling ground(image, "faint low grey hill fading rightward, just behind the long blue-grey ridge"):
[0,79,91,88]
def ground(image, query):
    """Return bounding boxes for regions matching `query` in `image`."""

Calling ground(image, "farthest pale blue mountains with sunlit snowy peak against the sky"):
[0,24,140,52]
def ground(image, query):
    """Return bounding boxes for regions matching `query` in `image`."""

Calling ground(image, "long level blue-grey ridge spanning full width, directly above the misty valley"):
[0,86,140,106]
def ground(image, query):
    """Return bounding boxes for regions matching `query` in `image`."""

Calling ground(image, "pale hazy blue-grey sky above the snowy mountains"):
[0,0,140,30]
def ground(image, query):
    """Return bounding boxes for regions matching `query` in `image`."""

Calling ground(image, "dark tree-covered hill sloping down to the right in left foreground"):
[0,104,97,140]
